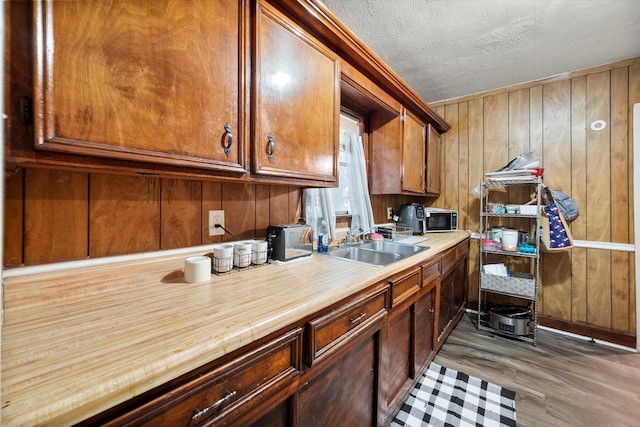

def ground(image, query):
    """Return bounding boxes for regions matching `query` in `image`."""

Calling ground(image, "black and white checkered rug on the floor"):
[391,362,516,427]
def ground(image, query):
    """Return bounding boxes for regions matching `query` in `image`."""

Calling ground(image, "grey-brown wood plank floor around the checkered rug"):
[434,314,640,427]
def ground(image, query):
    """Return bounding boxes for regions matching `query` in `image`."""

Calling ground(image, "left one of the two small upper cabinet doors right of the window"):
[402,112,426,194]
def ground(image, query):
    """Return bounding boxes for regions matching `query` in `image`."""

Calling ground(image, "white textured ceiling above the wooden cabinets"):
[320,0,640,102]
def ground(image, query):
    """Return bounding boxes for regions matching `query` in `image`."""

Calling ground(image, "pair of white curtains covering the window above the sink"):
[305,131,374,240]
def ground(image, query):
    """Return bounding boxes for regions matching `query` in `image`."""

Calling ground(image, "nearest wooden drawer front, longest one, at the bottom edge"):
[114,328,302,426]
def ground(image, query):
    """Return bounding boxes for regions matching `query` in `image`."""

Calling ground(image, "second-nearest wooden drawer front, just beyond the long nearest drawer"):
[307,286,389,366]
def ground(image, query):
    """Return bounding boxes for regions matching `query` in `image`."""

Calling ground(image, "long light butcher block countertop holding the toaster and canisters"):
[1,231,468,426]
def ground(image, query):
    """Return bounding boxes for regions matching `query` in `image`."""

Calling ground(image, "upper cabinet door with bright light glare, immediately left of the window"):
[252,2,340,185]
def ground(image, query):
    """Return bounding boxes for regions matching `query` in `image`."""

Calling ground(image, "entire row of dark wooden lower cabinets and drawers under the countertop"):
[81,240,469,427]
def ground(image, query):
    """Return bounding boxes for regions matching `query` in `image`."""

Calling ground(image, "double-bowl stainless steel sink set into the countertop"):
[326,241,429,267]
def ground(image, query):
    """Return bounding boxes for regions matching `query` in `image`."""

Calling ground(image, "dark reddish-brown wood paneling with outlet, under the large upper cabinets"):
[4,169,302,267]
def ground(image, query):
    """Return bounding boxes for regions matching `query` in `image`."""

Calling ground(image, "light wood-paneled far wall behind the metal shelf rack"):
[433,58,640,346]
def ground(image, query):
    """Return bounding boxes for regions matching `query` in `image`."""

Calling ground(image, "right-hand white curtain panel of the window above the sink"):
[341,132,374,235]
